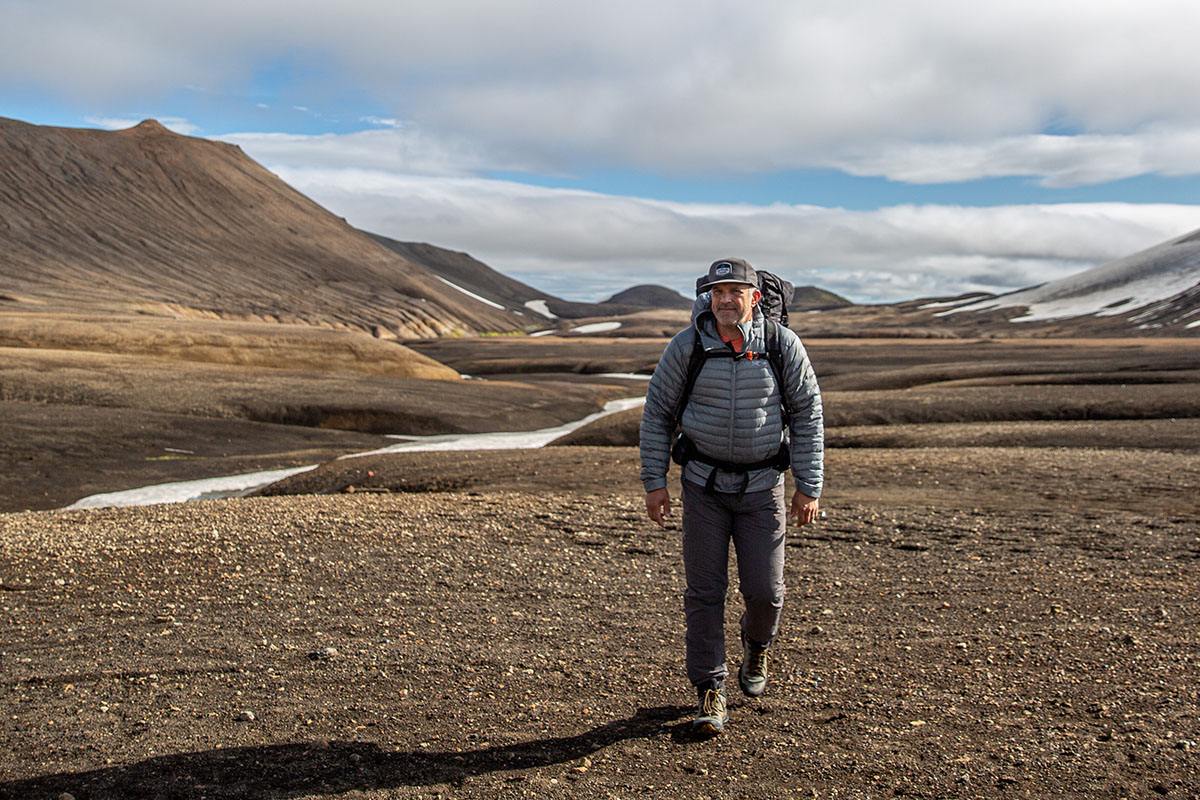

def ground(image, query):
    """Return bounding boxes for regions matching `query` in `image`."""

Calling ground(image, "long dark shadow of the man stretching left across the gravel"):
[0,705,689,800]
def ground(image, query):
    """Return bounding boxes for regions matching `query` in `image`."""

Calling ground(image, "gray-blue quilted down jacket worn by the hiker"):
[641,293,824,498]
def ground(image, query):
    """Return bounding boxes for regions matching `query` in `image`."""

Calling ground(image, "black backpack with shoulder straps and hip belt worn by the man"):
[671,270,796,497]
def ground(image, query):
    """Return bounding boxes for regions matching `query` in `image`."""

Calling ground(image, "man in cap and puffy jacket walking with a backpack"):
[641,258,824,734]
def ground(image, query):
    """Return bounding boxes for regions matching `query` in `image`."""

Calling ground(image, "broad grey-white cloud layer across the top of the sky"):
[7,0,1200,186]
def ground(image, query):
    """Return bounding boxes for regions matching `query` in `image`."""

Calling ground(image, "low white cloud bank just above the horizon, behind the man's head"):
[272,167,1200,302]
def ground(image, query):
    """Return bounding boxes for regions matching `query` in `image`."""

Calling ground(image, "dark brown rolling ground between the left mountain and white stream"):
[0,348,632,512]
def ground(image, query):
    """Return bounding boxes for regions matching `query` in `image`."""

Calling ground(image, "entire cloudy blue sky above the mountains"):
[0,0,1200,302]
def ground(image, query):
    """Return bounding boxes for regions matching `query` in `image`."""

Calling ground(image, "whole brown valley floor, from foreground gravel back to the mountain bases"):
[0,337,1200,800]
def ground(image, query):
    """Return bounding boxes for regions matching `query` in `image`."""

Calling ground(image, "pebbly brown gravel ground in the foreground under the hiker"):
[0,447,1200,800]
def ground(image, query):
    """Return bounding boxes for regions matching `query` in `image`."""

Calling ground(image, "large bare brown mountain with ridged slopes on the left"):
[0,118,529,338]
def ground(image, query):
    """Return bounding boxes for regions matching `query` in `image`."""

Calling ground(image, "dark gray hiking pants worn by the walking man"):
[683,480,787,685]
